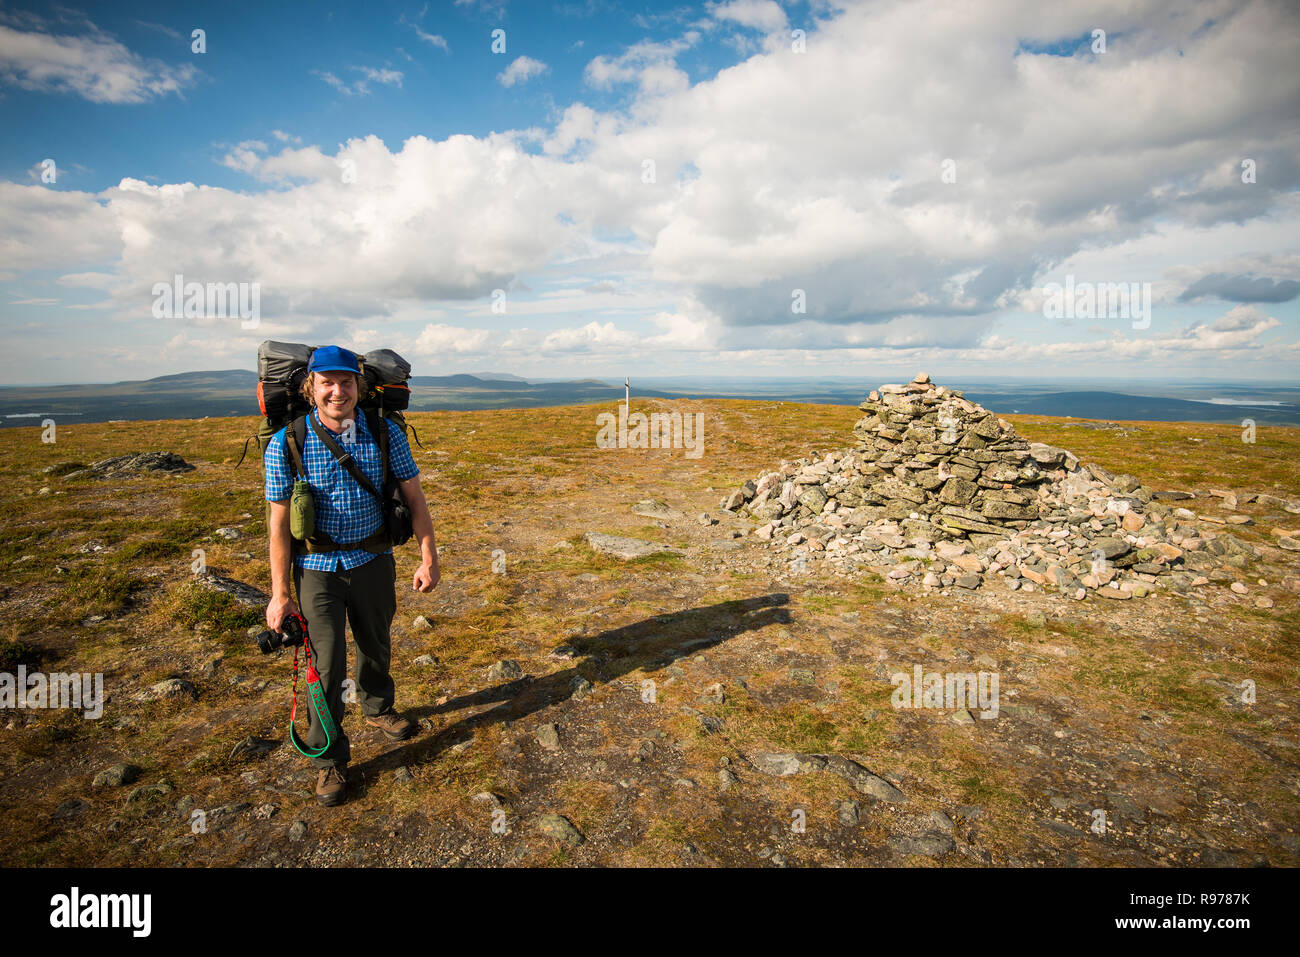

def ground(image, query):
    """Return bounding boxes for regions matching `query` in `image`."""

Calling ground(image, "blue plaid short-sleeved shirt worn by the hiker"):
[263,410,420,572]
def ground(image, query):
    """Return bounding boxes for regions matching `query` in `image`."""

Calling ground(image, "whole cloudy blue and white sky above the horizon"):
[0,0,1300,385]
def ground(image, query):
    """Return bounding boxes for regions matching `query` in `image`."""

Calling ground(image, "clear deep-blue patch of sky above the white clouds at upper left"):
[0,3,759,191]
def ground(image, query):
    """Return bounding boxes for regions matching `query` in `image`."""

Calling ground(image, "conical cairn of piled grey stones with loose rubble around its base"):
[722,373,1258,599]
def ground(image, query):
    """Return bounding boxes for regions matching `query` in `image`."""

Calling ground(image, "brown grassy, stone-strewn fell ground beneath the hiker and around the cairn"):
[0,390,1300,866]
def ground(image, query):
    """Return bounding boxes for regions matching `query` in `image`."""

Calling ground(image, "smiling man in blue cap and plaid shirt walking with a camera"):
[265,346,441,806]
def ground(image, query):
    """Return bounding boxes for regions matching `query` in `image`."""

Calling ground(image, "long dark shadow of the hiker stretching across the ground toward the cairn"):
[352,593,790,793]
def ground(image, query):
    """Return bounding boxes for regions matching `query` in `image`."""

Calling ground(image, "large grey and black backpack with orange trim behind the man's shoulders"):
[235,339,424,468]
